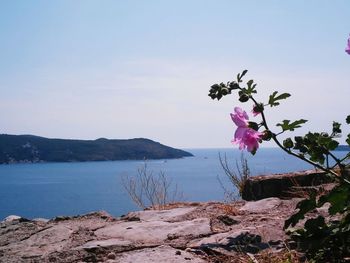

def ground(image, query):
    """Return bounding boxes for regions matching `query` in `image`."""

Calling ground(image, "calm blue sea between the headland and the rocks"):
[0,148,344,220]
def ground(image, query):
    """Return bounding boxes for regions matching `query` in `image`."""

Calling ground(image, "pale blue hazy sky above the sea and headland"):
[0,0,350,148]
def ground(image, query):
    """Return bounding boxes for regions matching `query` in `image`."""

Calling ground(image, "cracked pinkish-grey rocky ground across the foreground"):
[0,197,334,263]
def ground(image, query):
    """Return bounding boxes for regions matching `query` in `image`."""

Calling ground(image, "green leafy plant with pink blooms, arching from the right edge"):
[209,70,350,262]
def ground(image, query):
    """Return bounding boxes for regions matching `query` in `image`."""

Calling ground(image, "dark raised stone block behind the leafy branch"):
[242,170,333,201]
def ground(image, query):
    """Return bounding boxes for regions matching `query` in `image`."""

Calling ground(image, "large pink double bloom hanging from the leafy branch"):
[231,107,263,153]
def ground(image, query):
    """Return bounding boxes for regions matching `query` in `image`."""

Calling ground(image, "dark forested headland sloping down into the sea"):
[0,134,192,164]
